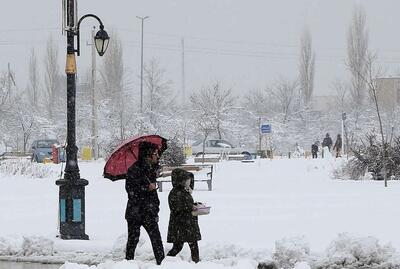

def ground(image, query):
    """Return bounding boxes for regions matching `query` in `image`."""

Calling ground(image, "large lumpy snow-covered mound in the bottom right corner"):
[316,233,400,269]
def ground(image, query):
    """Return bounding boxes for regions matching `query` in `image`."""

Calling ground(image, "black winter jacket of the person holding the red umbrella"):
[125,161,160,220]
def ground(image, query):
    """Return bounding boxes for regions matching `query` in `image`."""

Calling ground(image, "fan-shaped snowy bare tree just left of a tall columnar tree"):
[268,78,298,123]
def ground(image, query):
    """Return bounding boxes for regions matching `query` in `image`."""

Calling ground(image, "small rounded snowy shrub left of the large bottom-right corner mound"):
[273,237,310,269]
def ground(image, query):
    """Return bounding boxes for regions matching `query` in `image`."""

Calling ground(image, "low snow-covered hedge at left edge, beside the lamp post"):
[0,159,60,178]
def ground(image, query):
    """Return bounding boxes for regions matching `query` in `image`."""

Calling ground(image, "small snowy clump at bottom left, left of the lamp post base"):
[21,236,54,256]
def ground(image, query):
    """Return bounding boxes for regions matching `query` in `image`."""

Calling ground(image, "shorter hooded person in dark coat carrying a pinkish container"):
[167,168,201,263]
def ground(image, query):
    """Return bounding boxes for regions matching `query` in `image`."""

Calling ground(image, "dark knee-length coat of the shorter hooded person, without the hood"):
[167,185,201,243]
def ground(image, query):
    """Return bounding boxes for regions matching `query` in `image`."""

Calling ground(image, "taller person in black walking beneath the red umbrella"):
[125,142,164,264]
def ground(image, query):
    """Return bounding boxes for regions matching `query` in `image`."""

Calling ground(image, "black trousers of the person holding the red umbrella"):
[126,218,164,264]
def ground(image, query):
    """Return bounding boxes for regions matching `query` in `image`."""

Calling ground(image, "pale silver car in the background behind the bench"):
[192,139,251,157]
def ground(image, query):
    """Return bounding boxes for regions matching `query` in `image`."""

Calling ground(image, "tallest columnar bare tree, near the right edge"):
[346,3,368,108]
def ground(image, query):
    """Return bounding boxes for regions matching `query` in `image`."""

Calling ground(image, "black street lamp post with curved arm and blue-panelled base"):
[56,0,110,240]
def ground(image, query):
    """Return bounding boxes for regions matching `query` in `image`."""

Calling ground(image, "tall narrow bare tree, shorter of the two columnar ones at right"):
[299,25,315,105]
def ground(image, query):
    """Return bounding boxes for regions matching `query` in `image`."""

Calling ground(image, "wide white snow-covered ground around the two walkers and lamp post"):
[0,158,400,269]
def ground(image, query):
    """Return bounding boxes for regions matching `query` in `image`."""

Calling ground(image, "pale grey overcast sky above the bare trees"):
[0,0,400,95]
